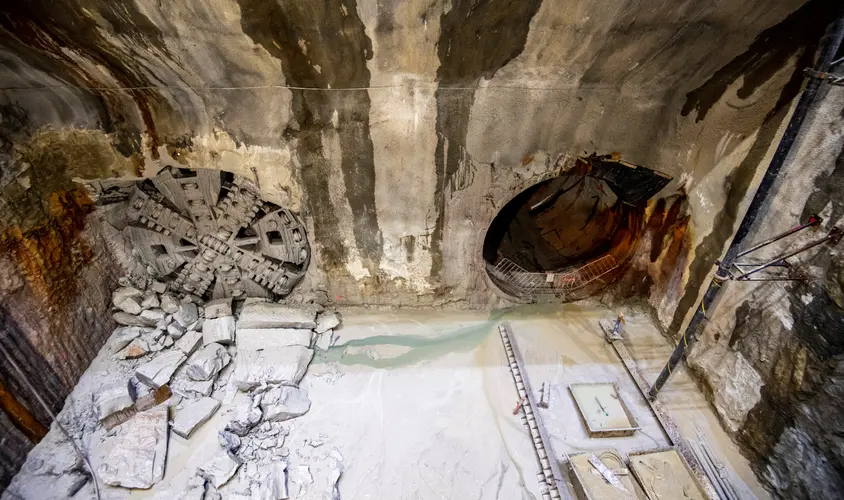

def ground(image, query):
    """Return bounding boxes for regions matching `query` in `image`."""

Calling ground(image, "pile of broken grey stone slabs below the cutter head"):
[93,281,342,500]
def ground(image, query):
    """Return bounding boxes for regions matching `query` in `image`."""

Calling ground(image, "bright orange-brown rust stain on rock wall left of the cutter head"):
[0,189,94,310]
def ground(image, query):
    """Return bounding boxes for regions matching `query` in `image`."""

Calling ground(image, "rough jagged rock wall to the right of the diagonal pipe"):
[690,87,844,498]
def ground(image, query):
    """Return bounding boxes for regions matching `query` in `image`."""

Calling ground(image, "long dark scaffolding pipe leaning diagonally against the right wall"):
[648,12,844,398]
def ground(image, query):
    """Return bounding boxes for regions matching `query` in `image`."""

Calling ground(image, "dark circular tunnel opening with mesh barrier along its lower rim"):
[483,155,670,300]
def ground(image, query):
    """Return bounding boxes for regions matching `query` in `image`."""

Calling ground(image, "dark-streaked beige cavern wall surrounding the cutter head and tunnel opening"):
[0,0,836,494]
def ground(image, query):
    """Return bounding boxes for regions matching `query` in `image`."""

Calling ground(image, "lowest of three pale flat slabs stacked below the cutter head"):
[233,346,314,391]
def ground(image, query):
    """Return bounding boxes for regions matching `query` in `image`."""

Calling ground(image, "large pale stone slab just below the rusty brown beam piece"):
[97,404,167,489]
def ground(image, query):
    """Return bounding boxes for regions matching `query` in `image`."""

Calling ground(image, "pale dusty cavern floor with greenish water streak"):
[3,304,768,499]
